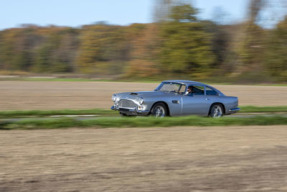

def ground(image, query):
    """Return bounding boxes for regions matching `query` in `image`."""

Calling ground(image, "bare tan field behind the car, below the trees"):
[0,81,287,110]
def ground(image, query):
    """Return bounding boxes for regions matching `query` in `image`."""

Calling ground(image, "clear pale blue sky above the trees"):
[0,0,286,30]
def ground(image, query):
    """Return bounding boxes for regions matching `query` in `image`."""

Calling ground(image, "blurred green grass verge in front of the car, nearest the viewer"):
[0,116,287,130]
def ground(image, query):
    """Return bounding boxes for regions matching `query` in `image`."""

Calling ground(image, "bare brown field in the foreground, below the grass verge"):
[0,126,287,192]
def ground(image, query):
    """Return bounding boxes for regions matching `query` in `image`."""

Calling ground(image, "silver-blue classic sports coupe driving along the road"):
[111,80,240,117]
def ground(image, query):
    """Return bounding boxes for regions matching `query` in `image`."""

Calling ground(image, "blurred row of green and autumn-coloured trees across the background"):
[0,4,287,81]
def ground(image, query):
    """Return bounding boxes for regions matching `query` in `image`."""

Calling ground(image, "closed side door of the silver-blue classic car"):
[182,85,210,115]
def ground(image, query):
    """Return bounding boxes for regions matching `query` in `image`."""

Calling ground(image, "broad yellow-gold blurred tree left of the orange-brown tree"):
[77,24,126,73]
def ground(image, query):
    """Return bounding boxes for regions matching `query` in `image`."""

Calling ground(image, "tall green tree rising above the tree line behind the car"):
[160,5,215,74]
